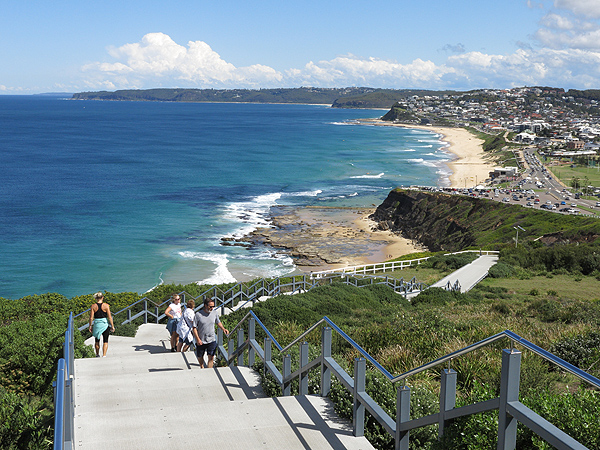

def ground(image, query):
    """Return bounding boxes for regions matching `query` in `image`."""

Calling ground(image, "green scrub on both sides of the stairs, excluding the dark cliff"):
[0,251,600,449]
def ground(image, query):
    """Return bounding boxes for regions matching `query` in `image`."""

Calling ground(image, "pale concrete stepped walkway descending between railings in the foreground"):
[74,324,373,450]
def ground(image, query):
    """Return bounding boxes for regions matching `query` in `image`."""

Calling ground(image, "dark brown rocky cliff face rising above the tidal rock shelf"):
[371,190,494,251]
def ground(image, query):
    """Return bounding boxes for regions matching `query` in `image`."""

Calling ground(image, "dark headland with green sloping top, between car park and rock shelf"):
[372,189,600,251]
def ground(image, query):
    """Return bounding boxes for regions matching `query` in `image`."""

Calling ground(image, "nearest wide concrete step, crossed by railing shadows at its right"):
[75,396,373,450]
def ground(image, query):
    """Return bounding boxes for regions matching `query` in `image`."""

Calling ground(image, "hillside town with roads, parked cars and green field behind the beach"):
[382,87,600,215]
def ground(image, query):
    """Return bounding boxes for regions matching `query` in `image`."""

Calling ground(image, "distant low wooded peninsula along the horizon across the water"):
[72,87,450,109]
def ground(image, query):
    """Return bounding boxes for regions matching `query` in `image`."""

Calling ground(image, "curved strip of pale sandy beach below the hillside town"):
[360,119,495,188]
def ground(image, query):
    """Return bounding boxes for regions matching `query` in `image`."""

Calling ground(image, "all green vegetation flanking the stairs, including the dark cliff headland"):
[0,190,600,449]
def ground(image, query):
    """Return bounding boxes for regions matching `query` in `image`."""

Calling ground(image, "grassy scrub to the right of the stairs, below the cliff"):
[225,253,600,449]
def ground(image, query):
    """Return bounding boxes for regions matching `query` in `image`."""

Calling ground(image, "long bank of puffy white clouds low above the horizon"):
[79,31,600,90]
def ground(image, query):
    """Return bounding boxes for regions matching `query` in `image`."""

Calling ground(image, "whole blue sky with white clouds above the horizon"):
[0,0,600,94]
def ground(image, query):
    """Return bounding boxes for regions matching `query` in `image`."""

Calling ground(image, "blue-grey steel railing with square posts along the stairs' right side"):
[218,311,600,450]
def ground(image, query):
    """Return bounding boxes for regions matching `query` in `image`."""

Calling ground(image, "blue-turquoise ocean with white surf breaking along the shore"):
[0,96,452,298]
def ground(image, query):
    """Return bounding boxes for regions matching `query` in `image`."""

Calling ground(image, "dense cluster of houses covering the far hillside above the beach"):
[384,87,600,156]
